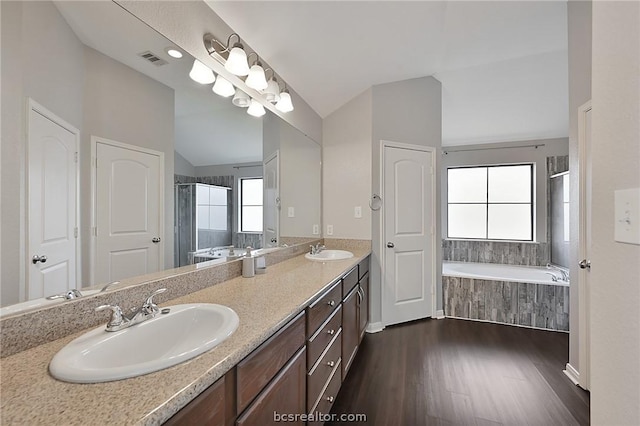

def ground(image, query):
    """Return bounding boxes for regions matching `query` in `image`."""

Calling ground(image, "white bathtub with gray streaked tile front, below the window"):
[442,262,569,332]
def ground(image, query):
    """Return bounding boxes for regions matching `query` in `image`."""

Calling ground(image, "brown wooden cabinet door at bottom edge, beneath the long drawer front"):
[236,347,307,426]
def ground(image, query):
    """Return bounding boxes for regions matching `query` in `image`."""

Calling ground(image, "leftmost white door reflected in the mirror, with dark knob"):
[26,102,79,299]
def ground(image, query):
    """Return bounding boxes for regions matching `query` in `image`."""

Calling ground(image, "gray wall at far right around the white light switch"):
[592,1,640,425]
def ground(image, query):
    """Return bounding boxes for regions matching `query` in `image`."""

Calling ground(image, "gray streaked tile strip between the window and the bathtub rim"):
[442,239,549,266]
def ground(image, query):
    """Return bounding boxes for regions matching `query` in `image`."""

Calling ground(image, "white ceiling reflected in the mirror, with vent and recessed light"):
[55,1,262,166]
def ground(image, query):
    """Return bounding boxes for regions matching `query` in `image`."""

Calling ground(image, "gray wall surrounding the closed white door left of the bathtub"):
[368,77,442,323]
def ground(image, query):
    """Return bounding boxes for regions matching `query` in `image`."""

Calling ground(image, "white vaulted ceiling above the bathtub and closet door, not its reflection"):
[207,1,569,145]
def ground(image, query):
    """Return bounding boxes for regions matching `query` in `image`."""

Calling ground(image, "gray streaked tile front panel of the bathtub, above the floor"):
[442,277,569,331]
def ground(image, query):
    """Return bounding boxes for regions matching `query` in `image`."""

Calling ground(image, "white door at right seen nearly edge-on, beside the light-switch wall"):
[578,102,592,390]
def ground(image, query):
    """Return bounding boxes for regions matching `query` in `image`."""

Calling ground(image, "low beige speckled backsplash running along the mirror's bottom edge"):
[0,240,321,358]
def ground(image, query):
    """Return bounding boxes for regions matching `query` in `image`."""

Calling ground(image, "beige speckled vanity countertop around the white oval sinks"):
[0,251,369,425]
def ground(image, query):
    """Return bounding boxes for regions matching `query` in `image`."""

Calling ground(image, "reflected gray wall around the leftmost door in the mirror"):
[0,1,85,306]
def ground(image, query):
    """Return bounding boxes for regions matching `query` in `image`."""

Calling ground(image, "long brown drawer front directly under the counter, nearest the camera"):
[237,312,305,413]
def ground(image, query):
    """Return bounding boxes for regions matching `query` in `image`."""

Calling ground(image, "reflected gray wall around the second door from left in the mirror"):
[80,47,175,282]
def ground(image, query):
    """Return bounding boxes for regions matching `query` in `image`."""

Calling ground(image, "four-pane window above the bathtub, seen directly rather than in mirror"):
[447,164,534,241]
